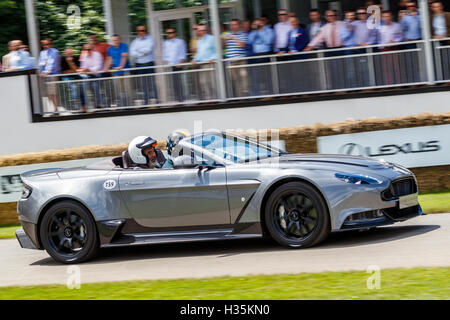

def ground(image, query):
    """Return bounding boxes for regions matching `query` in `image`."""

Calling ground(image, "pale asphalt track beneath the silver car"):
[0,214,450,286]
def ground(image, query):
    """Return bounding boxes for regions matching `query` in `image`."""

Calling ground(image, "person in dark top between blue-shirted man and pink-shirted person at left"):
[61,49,86,109]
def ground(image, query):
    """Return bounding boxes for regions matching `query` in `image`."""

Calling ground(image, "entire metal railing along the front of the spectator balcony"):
[37,39,450,114]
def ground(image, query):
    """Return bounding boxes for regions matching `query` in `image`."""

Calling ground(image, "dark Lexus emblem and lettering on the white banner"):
[338,140,441,157]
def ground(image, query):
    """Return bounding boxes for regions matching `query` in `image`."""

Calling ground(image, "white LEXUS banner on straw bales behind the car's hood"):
[318,125,450,168]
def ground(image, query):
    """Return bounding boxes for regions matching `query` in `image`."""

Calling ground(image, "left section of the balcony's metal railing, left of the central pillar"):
[41,63,217,114]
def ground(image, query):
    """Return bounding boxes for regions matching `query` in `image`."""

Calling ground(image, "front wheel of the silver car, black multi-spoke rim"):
[264,182,330,248]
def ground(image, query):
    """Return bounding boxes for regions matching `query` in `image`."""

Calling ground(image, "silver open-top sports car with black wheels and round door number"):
[16,132,422,263]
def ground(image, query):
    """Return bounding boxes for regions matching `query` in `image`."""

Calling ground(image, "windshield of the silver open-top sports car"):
[191,133,282,163]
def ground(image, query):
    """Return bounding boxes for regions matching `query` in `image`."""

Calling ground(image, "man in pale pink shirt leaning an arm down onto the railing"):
[305,10,344,51]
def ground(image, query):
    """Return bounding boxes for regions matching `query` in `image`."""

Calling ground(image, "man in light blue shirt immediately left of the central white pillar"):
[192,25,217,100]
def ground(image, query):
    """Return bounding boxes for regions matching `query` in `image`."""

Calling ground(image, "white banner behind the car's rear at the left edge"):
[0,157,108,203]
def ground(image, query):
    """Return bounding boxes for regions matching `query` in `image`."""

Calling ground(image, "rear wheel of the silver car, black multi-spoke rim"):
[39,200,99,264]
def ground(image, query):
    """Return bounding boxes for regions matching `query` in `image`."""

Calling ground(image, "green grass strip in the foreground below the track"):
[0,268,450,300]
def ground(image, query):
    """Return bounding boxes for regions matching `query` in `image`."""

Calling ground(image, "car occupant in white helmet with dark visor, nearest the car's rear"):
[128,136,166,169]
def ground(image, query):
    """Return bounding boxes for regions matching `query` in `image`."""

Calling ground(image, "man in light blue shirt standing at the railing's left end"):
[39,38,61,112]
